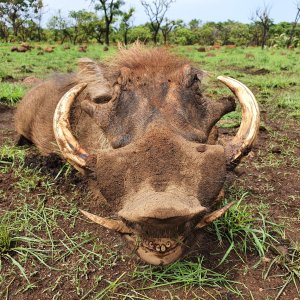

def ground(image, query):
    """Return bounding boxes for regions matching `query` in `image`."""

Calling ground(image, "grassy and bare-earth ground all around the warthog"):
[0,45,300,300]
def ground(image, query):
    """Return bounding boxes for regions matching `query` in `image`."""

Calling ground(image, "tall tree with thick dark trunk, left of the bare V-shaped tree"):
[91,0,124,46]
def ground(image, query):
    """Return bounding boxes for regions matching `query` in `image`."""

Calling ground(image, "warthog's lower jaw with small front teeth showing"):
[125,234,185,266]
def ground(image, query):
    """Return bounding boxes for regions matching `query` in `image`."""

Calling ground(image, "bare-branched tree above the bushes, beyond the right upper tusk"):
[252,6,273,49]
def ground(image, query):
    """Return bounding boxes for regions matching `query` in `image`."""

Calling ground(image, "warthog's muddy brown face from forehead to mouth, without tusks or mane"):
[82,62,234,264]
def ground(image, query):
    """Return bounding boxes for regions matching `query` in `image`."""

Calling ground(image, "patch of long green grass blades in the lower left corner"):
[0,196,122,295]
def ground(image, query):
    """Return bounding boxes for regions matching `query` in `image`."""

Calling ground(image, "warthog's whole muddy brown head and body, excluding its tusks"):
[16,50,256,264]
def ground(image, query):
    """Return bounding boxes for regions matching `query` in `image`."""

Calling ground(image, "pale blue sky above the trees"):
[44,0,300,25]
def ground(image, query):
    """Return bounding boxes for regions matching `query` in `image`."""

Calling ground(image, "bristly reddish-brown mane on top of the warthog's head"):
[109,43,190,74]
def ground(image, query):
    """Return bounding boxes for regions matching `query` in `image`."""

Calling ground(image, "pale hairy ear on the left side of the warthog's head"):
[77,58,112,103]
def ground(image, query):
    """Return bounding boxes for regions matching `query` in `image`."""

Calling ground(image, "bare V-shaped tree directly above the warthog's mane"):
[141,0,175,44]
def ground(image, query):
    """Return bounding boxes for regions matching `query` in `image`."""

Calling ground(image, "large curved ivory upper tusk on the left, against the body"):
[53,83,88,171]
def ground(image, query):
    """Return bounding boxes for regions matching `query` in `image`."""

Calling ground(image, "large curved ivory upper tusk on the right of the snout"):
[218,76,260,166]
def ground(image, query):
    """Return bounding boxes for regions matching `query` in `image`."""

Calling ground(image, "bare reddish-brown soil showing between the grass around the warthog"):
[0,102,300,300]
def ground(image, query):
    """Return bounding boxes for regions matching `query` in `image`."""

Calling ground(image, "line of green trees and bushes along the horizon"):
[0,0,300,47]
